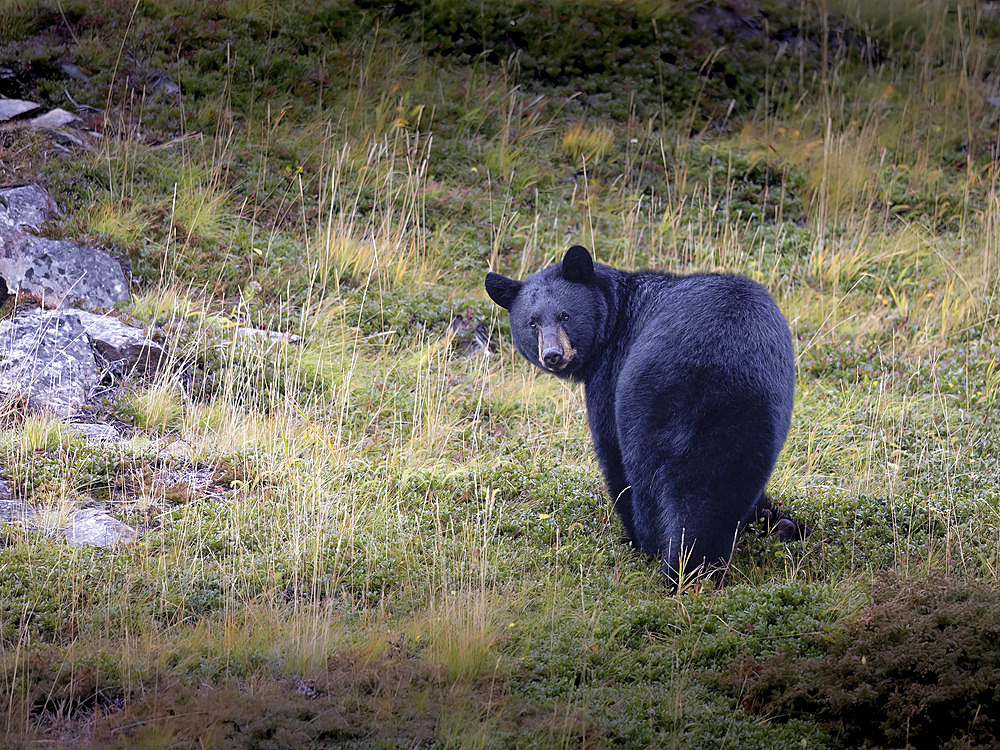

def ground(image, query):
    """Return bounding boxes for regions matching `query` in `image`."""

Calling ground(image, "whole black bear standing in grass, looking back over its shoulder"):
[486,250,795,583]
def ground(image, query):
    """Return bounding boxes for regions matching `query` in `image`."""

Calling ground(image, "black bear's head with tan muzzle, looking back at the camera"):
[486,245,607,377]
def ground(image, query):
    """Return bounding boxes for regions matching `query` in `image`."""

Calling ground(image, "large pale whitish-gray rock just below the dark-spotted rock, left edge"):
[0,310,164,416]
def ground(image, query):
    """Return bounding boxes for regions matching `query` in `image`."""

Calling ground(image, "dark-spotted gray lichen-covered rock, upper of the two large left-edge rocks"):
[0,184,130,311]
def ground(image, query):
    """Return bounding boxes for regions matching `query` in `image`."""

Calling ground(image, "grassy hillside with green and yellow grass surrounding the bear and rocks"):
[0,0,1000,748]
